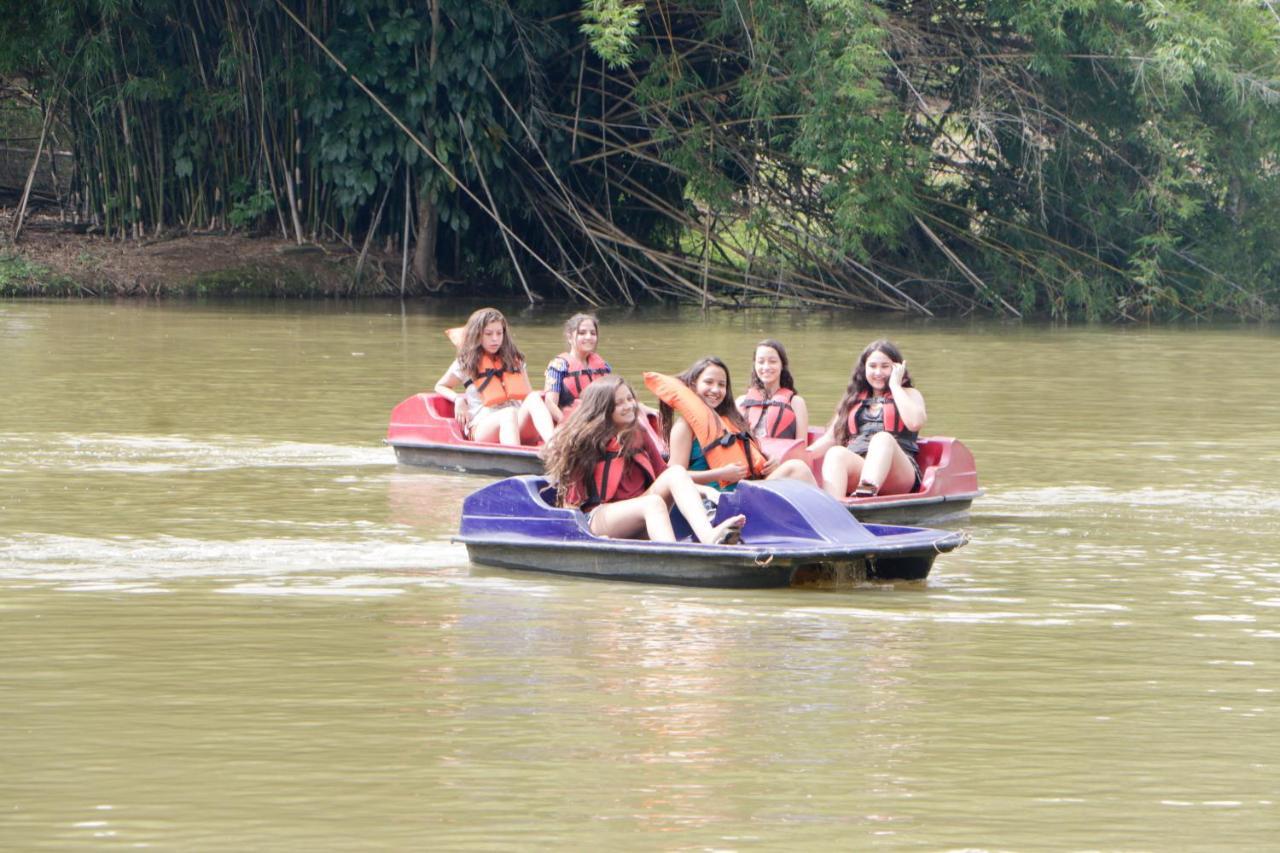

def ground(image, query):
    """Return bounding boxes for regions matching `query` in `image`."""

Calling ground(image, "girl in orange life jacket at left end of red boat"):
[435,307,556,444]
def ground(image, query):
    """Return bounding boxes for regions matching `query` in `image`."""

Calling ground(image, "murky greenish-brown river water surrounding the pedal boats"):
[0,301,1280,850]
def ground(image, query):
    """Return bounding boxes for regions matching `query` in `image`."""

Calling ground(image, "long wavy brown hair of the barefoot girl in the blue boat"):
[541,377,644,505]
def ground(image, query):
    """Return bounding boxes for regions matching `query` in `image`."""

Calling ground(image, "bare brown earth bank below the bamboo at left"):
[0,211,399,297]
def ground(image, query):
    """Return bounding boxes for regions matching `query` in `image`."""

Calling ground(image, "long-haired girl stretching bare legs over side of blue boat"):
[543,377,746,544]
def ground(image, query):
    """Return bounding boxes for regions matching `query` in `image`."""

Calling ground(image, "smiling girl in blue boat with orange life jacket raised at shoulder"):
[645,356,817,491]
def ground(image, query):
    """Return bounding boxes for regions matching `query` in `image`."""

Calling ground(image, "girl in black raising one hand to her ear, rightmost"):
[809,341,925,498]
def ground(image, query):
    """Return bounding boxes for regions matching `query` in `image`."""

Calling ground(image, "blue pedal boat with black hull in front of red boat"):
[454,476,969,588]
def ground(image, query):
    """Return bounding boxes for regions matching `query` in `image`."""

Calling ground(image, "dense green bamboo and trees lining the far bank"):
[0,0,1280,319]
